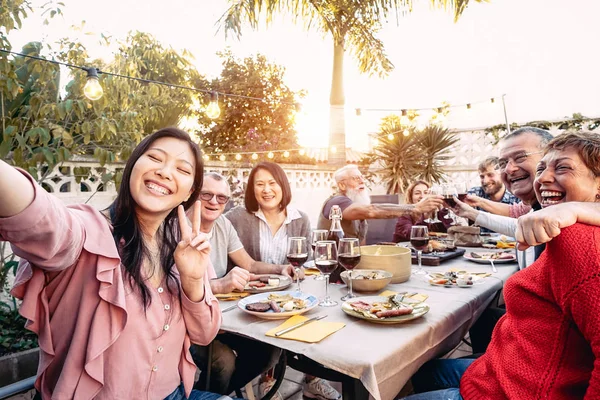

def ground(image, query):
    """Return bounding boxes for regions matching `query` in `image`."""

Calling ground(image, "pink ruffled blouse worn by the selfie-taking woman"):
[0,171,221,400]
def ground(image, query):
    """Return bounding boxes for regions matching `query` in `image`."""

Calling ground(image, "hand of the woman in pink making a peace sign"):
[174,201,210,301]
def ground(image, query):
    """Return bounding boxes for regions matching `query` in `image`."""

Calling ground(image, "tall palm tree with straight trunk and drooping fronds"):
[219,0,486,164]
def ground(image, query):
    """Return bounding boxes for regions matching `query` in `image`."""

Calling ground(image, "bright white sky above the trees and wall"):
[10,0,600,150]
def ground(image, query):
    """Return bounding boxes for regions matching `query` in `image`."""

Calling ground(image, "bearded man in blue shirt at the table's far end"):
[468,156,520,232]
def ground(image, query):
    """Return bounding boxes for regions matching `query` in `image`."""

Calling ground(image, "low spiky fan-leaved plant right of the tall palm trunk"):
[367,115,459,193]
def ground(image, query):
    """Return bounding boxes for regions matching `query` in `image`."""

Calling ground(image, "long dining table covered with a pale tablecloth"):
[221,248,519,400]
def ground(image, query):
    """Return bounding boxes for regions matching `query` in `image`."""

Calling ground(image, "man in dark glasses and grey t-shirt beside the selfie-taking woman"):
[190,172,290,394]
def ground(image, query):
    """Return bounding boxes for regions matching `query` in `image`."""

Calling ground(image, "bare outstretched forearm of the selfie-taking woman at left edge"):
[0,160,35,218]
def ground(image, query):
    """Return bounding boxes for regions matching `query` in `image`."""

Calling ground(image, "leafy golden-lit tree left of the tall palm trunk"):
[198,51,310,162]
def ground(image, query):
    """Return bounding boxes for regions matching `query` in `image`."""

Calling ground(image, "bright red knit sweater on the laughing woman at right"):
[460,224,600,400]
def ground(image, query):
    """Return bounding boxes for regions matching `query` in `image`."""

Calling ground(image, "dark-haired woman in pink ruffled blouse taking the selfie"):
[0,128,221,400]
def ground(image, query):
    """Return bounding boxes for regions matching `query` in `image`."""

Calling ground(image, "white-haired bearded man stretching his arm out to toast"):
[317,164,444,244]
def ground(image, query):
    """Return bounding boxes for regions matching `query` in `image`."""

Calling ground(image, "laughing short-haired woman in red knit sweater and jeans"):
[408,132,600,400]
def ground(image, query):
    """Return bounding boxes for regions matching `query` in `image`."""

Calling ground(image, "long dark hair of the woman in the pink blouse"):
[109,127,204,309]
